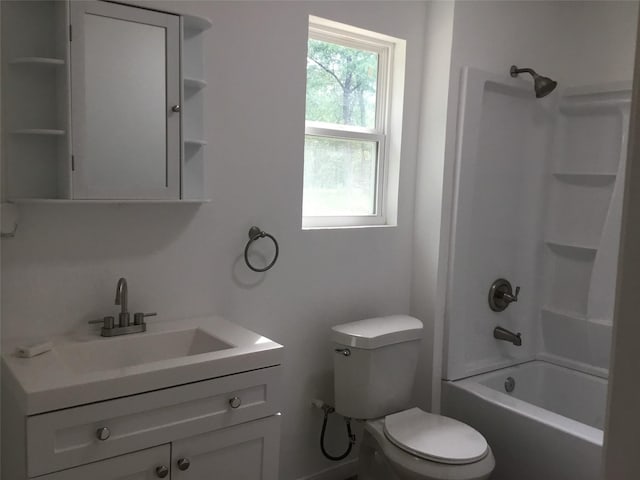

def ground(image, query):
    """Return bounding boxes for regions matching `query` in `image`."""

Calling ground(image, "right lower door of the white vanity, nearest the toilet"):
[171,414,280,480]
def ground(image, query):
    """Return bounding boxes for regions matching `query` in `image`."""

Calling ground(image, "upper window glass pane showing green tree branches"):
[306,38,378,128]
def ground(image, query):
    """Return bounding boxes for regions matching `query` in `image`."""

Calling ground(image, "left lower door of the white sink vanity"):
[38,445,171,480]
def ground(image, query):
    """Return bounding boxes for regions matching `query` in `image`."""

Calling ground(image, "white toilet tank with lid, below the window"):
[331,315,422,419]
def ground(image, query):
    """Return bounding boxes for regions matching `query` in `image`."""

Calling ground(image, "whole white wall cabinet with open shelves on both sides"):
[0,0,211,202]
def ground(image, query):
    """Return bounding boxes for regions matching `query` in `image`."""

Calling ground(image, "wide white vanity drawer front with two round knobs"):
[27,366,282,477]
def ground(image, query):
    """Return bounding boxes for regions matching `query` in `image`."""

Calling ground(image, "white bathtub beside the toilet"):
[442,360,607,480]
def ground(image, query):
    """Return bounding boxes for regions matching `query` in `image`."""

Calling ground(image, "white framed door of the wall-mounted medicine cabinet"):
[71,1,181,200]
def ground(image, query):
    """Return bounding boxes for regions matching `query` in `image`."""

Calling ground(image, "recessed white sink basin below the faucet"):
[55,328,233,373]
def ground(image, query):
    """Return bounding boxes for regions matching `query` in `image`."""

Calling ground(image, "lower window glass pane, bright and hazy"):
[302,135,378,216]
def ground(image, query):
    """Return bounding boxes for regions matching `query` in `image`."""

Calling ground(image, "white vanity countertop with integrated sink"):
[2,317,283,415]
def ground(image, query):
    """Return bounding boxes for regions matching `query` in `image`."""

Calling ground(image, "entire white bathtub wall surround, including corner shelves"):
[444,69,630,379]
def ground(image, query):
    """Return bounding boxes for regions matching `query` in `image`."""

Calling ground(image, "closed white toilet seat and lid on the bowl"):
[384,408,489,465]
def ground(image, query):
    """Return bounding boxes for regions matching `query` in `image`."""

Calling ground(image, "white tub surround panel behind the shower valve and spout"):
[444,69,552,379]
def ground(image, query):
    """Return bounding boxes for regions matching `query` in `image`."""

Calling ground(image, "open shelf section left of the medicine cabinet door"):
[1,1,71,199]
